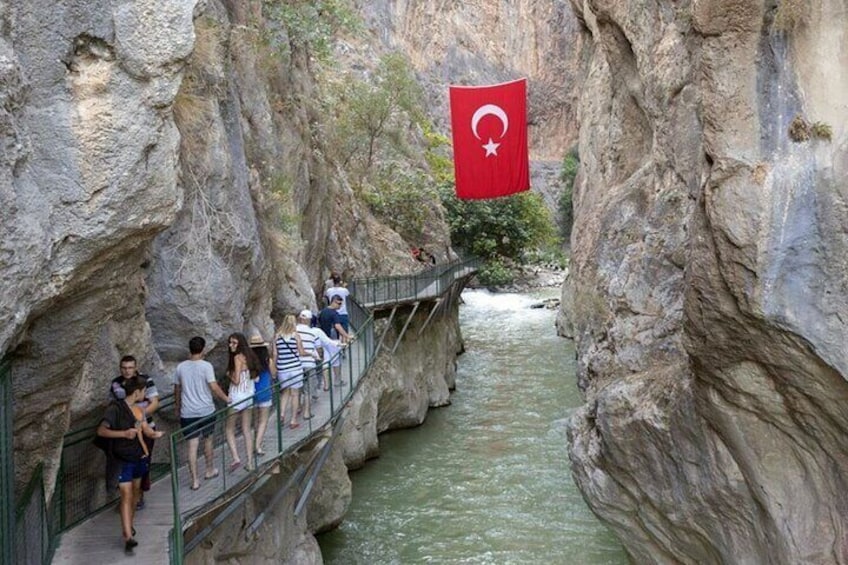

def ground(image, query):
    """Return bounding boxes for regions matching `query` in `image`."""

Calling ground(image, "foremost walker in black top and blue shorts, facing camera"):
[97,376,165,552]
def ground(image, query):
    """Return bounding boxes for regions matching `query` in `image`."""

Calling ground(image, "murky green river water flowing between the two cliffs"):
[318,290,627,565]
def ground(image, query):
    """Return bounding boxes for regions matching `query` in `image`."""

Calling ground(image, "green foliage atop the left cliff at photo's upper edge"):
[263,0,362,62]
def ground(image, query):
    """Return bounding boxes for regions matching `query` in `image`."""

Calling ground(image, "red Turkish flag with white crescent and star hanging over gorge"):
[450,79,530,199]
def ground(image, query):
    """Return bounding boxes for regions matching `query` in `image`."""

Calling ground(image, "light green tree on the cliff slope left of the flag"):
[322,53,450,242]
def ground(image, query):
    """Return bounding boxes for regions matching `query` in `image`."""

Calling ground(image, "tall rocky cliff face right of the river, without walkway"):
[564,0,848,564]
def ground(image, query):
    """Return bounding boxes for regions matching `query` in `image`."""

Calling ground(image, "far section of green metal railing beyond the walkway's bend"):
[349,258,481,308]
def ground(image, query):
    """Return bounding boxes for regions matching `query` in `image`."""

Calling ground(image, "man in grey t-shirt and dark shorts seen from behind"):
[174,336,230,490]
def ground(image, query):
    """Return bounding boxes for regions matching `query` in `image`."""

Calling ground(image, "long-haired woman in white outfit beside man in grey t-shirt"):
[224,333,259,471]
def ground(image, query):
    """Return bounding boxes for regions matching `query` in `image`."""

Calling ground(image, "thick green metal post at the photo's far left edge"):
[0,358,16,563]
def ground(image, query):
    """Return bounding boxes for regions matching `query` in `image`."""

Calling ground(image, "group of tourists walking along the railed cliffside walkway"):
[97,273,353,552]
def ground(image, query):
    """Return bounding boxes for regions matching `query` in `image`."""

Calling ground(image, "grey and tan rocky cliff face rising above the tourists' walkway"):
[0,0,434,496]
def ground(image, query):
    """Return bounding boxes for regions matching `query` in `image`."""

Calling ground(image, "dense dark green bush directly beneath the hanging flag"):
[440,185,556,259]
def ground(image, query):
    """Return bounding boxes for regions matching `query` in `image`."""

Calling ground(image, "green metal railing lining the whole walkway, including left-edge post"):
[8,259,480,565]
